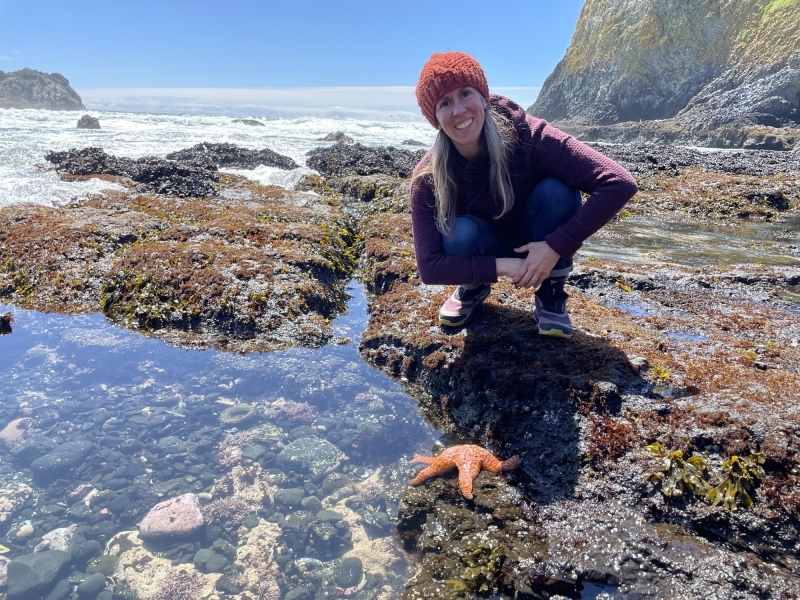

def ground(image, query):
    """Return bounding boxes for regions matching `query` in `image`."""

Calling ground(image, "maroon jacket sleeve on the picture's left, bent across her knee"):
[411,176,497,285]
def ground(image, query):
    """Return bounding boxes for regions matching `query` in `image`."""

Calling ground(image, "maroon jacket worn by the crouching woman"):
[411,95,638,285]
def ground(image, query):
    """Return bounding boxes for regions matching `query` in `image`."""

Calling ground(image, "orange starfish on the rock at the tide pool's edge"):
[411,444,519,500]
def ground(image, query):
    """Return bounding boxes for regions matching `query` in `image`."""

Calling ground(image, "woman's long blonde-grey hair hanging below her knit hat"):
[414,104,516,235]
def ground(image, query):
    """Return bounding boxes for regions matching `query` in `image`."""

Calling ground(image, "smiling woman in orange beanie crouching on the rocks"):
[411,52,637,338]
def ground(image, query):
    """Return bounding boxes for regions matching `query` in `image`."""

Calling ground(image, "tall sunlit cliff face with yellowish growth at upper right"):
[529,0,800,127]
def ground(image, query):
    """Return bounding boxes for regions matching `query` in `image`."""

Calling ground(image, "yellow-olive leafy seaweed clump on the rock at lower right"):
[645,442,765,510]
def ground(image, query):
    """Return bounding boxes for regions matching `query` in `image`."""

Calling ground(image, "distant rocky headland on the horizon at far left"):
[0,69,86,110]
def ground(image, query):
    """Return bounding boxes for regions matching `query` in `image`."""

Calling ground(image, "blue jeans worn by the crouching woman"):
[442,177,582,278]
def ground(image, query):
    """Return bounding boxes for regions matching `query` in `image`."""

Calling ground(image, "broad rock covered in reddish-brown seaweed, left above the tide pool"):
[0,176,355,350]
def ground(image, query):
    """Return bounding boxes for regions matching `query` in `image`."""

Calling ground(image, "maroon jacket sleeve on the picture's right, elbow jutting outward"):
[529,117,639,257]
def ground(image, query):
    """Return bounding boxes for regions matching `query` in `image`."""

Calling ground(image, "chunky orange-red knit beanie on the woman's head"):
[417,52,489,129]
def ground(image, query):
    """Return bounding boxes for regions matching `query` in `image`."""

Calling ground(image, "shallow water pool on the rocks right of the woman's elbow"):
[582,216,800,267]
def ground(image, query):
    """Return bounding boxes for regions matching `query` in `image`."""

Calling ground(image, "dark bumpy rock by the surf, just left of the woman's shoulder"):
[306,143,425,178]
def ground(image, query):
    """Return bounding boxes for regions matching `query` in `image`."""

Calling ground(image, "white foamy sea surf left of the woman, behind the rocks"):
[0,109,436,207]
